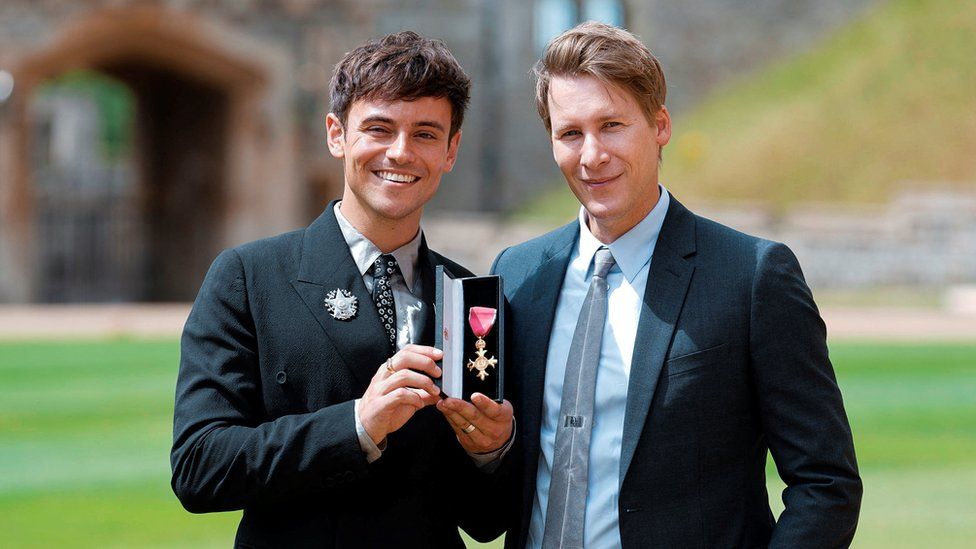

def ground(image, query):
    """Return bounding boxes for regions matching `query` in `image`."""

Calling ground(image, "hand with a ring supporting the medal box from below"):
[437,393,513,454]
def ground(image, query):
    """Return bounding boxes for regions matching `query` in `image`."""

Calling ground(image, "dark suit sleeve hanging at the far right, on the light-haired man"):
[750,244,862,548]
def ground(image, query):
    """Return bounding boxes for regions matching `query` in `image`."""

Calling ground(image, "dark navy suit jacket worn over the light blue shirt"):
[492,198,861,548]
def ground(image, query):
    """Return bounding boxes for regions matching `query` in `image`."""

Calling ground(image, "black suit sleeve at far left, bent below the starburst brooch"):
[170,250,366,513]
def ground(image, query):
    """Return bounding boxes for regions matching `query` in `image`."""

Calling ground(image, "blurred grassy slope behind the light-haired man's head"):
[525,0,976,219]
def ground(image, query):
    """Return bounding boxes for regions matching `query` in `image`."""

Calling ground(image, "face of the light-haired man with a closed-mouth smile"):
[549,76,671,243]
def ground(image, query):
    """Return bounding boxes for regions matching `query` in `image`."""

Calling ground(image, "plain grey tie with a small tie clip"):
[542,247,614,549]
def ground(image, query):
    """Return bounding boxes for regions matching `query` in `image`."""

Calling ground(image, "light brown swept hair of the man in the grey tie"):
[533,21,667,131]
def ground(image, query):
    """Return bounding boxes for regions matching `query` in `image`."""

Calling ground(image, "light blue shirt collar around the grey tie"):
[579,185,671,282]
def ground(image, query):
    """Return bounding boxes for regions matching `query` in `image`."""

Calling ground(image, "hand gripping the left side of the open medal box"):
[359,345,443,445]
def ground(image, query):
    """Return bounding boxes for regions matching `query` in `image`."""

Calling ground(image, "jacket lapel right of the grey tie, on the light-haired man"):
[620,197,695,483]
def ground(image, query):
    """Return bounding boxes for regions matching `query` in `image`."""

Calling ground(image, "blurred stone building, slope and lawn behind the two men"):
[0,0,976,547]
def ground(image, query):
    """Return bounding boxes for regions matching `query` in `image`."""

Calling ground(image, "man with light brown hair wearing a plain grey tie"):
[492,23,861,548]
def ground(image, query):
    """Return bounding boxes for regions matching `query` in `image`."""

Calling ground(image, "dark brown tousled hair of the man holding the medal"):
[329,31,471,136]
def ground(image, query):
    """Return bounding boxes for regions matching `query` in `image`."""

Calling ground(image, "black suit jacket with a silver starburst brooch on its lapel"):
[171,204,500,547]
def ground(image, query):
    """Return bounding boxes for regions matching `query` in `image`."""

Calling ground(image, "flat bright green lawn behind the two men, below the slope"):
[0,341,976,548]
